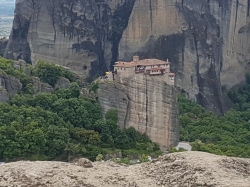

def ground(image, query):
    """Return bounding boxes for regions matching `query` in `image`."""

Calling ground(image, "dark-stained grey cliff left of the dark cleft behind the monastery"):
[5,0,135,76]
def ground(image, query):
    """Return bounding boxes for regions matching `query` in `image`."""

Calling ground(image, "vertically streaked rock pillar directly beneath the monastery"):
[98,76,179,149]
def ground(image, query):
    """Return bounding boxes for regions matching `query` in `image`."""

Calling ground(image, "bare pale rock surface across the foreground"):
[0,151,250,187]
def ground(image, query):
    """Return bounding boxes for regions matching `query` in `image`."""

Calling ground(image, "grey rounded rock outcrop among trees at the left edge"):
[0,71,23,102]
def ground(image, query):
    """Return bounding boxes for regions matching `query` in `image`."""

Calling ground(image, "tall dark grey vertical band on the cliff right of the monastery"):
[178,4,227,114]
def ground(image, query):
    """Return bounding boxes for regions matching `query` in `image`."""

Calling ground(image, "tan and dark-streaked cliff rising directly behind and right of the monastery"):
[119,0,250,113]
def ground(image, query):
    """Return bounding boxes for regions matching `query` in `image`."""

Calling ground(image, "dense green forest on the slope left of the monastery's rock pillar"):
[0,58,161,161]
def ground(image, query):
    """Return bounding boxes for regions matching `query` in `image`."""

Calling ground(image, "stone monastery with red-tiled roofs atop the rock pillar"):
[105,56,175,85]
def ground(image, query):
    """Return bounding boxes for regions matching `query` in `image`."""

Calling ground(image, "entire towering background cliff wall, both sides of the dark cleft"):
[5,0,250,114]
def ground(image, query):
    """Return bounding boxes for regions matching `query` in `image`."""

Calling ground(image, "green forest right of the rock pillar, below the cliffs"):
[179,79,250,158]
